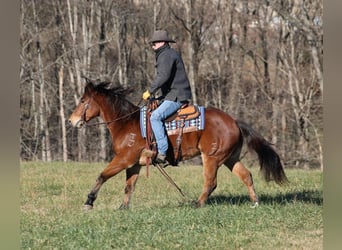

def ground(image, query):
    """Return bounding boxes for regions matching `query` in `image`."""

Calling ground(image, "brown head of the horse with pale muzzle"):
[69,82,100,128]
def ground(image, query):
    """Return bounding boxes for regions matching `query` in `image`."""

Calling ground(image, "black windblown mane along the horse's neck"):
[88,82,139,118]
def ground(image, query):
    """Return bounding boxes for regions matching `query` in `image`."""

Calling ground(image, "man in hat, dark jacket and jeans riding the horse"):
[143,30,191,166]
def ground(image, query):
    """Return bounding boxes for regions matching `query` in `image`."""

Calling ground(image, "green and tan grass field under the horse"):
[20,162,323,250]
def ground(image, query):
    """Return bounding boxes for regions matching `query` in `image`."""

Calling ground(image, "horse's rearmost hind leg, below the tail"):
[226,161,259,206]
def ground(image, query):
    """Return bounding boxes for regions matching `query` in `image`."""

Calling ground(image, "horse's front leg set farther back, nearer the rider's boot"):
[120,164,141,209]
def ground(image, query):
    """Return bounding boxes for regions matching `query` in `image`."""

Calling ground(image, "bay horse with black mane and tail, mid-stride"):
[69,80,287,210]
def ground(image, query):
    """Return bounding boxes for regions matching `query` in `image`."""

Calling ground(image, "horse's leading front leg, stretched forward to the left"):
[84,157,127,210]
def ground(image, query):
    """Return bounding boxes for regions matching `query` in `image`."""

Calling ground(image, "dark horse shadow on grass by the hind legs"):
[207,190,323,206]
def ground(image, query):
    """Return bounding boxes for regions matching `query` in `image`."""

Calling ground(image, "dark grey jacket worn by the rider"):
[149,44,191,102]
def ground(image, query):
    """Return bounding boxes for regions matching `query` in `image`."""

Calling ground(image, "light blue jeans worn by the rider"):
[150,100,182,155]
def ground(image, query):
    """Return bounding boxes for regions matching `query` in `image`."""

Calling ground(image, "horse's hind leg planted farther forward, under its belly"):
[196,154,218,207]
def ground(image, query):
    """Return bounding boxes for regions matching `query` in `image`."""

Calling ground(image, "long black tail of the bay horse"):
[236,120,288,184]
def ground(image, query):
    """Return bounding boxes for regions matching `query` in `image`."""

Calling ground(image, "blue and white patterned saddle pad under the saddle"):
[140,106,205,138]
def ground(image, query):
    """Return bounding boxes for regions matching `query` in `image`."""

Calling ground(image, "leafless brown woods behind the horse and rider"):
[20,0,323,168]
